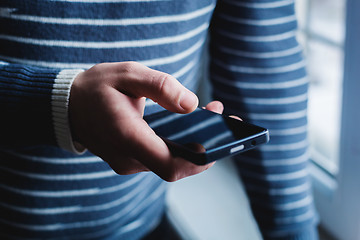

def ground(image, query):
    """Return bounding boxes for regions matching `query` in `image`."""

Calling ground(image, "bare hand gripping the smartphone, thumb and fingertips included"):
[69,62,222,181]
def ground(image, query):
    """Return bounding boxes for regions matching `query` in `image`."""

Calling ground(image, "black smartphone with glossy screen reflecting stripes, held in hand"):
[144,108,269,165]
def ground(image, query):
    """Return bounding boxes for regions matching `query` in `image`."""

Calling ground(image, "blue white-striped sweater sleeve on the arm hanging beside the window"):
[210,0,317,240]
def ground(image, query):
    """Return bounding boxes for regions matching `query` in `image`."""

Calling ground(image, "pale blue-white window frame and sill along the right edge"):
[310,0,360,240]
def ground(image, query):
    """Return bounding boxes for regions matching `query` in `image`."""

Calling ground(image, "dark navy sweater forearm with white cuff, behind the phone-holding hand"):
[0,62,83,153]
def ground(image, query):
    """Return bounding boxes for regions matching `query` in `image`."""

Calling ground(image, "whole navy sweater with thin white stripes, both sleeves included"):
[0,0,316,239]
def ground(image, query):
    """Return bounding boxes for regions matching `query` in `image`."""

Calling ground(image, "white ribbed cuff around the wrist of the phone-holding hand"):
[51,69,86,154]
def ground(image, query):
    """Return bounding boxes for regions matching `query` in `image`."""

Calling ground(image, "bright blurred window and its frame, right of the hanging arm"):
[296,0,360,240]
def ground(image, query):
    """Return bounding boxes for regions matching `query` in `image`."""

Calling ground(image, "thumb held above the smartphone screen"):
[117,63,199,113]
